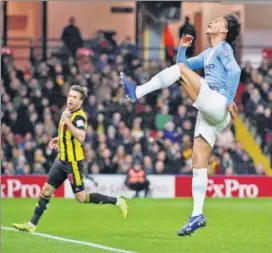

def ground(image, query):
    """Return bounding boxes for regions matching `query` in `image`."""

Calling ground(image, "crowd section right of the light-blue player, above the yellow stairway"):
[240,58,272,167]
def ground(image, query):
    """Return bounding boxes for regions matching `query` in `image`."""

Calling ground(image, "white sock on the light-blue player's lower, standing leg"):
[192,169,208,216]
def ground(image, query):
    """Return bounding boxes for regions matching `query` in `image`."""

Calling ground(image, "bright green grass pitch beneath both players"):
[1,199,272,253]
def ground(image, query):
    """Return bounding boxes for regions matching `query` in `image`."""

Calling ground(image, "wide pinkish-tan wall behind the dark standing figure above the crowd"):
[48,1,136,41]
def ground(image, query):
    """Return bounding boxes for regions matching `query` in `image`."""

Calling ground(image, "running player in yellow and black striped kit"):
[13,85,128,232]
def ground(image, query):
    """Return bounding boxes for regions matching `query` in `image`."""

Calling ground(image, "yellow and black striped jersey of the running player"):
[58,108,88,162]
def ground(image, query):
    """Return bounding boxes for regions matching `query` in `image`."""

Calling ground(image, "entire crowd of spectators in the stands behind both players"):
[1,31,272,175]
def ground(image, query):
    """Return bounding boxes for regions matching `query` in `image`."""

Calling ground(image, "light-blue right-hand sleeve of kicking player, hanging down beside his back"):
[217,44,241,105]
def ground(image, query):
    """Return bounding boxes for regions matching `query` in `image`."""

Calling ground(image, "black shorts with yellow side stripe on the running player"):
[47,159,85,193]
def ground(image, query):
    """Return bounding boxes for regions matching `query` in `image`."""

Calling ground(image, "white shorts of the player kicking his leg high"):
[193,79,231,147]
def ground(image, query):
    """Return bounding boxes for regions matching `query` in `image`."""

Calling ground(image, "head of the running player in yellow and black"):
[67,85,88,111]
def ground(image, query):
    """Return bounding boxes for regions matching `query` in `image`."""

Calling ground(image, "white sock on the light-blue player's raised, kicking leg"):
[136,64,180,99]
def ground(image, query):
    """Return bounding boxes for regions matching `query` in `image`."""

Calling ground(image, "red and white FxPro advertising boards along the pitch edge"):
[1,175,272,198]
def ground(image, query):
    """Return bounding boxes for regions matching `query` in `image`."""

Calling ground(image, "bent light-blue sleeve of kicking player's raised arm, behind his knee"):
[177,46,204,70]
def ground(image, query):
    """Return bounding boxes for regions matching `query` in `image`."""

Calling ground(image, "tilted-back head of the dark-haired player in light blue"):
[206,14,241,45]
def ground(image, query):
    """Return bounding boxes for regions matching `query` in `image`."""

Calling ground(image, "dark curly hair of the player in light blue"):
[225,14,241,48]
